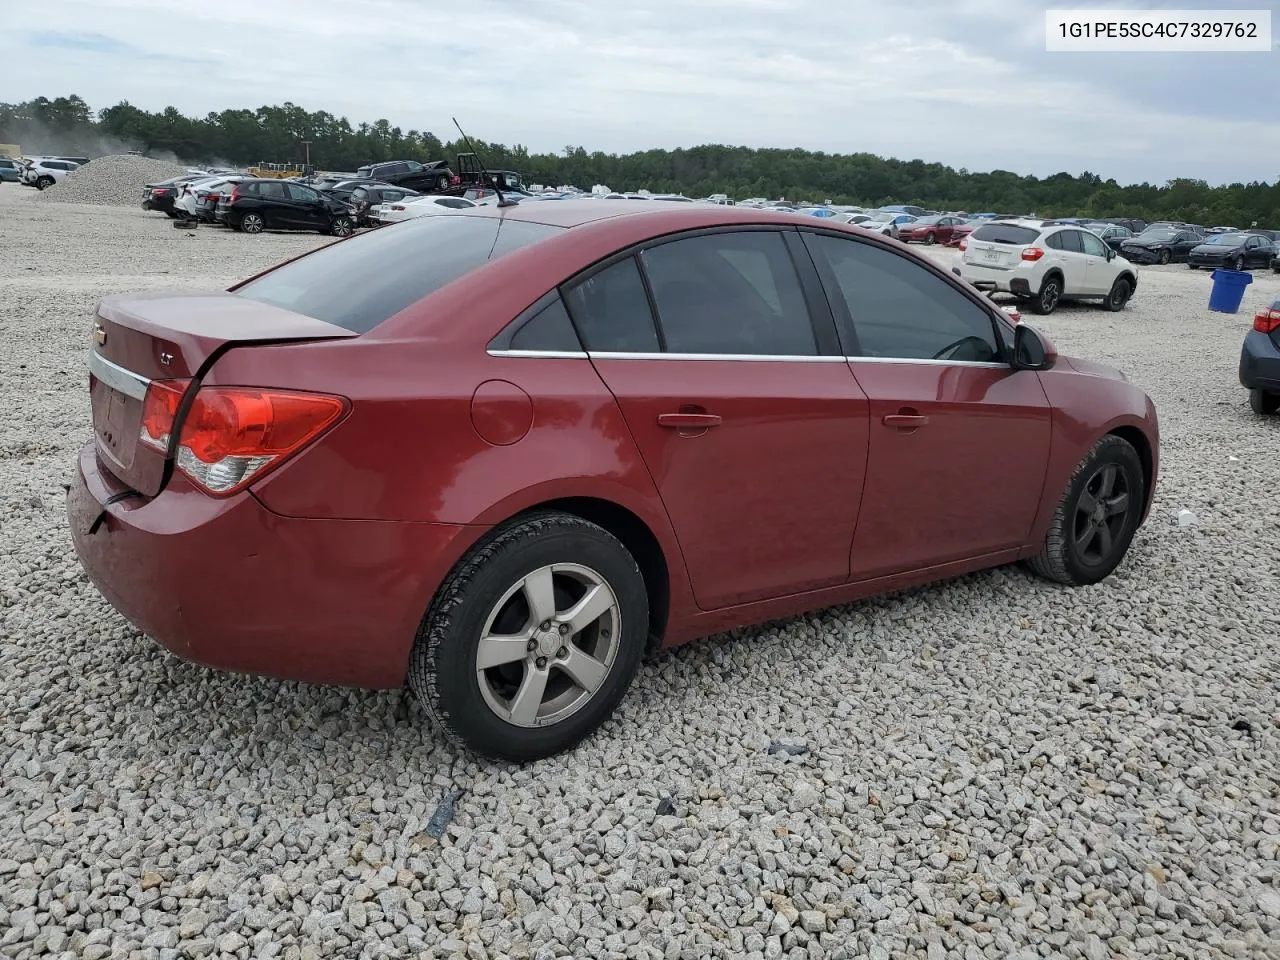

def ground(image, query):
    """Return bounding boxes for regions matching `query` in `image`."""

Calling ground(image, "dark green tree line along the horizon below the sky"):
[0,95,1280,229]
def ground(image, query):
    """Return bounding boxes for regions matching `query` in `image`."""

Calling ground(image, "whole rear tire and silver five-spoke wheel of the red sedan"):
[408,511,649,763]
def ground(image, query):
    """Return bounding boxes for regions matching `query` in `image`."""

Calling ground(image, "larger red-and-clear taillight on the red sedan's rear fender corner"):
[177,387,347,497]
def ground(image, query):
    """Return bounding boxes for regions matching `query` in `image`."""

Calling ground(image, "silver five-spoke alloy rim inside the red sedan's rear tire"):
[475,563,622,727]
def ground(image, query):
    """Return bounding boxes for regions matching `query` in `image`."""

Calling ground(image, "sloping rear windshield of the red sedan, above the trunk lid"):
[236,216,563,333]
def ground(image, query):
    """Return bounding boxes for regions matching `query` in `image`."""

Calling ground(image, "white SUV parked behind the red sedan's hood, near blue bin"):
[954,220,1138,314]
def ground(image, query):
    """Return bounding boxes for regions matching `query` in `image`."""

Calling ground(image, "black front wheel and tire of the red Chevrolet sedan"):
[1028,434,1147,586]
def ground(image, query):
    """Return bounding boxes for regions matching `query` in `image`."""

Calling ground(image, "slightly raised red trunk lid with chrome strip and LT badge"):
[90,292,356,497]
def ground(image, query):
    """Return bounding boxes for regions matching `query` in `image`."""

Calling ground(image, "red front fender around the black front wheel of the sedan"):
[1032,357,1160,550]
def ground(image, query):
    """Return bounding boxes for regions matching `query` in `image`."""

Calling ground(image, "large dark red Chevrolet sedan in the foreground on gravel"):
[68,201,1158,760]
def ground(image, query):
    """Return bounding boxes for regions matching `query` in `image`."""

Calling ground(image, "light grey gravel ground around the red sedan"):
[0,187,1280,960]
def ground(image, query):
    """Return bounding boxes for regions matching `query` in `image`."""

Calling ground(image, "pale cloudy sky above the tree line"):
[0,0,1280,183]
